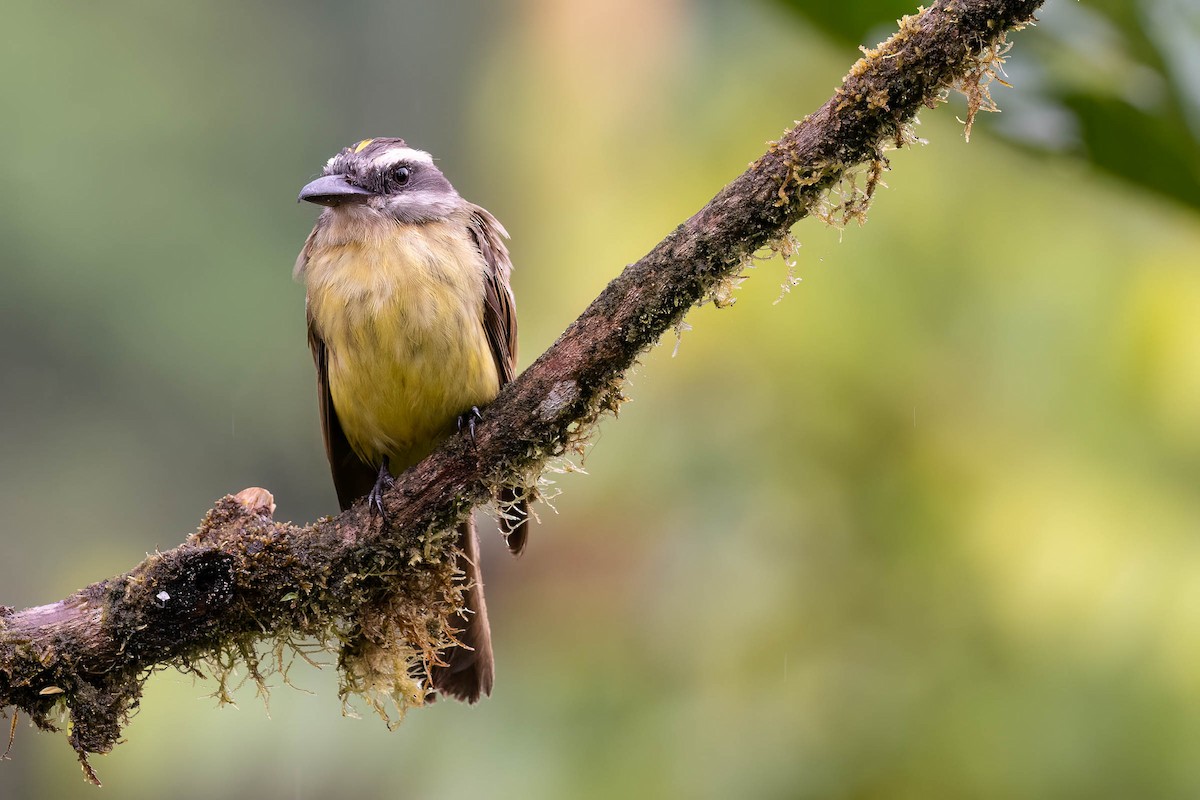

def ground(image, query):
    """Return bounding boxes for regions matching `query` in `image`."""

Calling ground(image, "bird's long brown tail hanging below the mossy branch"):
[430,518,496,703]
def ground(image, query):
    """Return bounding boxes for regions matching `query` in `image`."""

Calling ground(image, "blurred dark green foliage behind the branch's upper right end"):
[769,0,1200,209]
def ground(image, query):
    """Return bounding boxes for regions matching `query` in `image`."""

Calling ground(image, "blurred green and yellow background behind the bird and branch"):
[0,0,1200,800]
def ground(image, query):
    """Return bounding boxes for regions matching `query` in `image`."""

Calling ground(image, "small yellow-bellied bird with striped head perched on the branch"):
[295,137,528,703]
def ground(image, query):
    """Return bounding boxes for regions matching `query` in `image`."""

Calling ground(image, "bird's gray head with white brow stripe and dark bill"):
[299,138,464,223]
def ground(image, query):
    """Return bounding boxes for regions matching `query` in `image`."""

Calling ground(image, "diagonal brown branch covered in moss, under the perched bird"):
[0,0,1042,780]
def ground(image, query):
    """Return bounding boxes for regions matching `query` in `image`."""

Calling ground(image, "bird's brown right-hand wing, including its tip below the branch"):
[470,205,529,555]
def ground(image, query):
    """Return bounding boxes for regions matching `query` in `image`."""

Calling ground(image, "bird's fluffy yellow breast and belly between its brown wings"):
[305,215,499,474]
